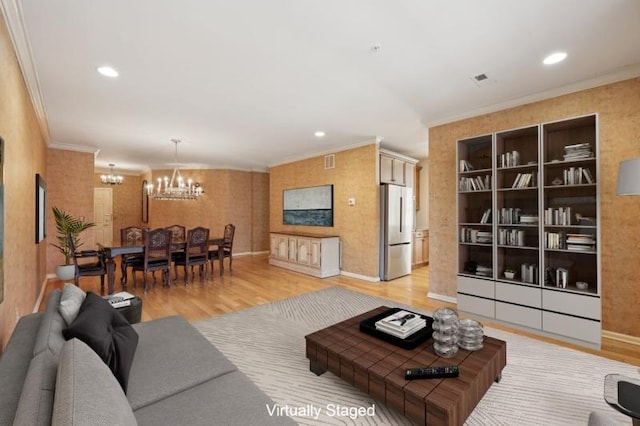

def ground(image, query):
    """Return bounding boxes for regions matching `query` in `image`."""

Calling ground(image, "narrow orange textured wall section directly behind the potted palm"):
[47,149,95,274]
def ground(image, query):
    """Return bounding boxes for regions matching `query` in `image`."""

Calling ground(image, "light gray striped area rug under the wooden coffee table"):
[194,287,638,426]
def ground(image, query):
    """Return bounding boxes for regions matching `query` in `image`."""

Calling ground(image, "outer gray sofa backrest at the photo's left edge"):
[0,312,44,426]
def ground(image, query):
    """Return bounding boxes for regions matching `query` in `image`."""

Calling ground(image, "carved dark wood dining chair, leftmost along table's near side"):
[132,228,171,292]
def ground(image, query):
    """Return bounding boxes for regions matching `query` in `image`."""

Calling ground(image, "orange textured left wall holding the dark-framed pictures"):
[0,14,47,352]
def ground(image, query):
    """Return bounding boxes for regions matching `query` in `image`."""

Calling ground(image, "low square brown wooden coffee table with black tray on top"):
[305,306,507,425]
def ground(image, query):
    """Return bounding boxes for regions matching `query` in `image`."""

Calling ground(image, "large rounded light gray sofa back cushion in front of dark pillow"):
[52,339,137,426]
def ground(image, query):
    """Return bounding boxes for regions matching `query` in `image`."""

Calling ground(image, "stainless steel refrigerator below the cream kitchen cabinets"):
[380,184,413,281]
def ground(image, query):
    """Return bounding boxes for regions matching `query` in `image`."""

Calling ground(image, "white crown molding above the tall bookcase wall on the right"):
[423,64,640,128]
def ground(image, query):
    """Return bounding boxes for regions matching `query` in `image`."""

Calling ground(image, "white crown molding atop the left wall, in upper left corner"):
[0,0,51,146]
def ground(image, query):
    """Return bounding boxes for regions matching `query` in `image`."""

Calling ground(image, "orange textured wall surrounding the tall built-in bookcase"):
[429,78,640,336]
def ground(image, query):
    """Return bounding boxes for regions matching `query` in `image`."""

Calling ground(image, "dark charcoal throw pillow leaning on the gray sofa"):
[62,292,138,393]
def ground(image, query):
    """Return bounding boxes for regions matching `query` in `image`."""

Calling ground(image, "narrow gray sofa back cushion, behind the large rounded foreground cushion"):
[13,351,58,426]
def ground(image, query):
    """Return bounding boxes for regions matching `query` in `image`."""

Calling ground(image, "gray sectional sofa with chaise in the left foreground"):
[0,290,295,426]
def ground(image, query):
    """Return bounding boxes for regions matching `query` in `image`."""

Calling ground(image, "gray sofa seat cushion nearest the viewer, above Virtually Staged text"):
[133,371,297,426]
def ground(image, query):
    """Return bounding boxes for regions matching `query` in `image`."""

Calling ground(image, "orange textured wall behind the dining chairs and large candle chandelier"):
[149,170,269,254]
